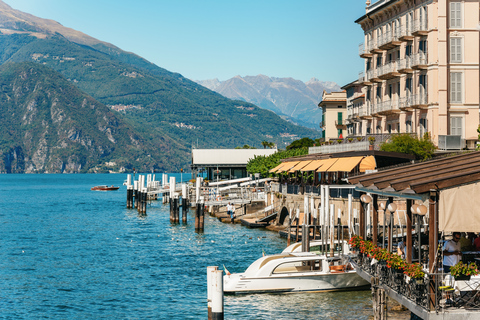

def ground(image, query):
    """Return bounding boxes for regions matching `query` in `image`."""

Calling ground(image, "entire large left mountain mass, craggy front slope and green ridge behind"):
[0,0,318,173]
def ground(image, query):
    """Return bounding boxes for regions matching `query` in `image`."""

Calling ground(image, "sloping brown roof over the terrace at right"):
[348,151,480,194]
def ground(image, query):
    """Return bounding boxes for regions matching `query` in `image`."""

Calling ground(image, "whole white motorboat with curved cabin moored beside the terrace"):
[223,252,370,294]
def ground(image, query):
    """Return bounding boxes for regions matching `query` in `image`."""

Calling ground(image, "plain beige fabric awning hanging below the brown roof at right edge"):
[438,182,480,233]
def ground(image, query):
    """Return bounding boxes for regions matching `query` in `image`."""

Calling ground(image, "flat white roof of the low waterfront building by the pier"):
[192,149,277,166]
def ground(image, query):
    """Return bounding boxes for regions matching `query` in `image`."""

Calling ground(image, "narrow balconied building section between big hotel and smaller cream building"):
[342,80,370,137]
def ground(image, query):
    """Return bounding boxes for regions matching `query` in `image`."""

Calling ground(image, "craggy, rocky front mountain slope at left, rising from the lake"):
[0,62,184,173]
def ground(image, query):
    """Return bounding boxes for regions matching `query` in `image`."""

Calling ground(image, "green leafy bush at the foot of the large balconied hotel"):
[380,133,436,160]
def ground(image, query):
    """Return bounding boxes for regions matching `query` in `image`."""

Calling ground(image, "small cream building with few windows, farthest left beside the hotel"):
[318,90,347,140]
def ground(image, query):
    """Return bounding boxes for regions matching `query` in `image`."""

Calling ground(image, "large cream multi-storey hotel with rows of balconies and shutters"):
[355,0,479,148]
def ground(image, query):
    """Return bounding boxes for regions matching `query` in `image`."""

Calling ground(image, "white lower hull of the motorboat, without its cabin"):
[223,271,370,294]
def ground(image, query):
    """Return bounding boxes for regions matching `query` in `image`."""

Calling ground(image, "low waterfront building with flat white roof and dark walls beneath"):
[190,148,277,181]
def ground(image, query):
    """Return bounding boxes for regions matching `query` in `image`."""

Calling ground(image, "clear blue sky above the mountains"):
[3,0,368,86]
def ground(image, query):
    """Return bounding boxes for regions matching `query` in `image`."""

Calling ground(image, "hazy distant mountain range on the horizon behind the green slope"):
[196,75,340,129]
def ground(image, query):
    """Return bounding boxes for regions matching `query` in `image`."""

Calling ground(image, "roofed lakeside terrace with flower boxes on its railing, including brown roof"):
[348,152,480,319]
